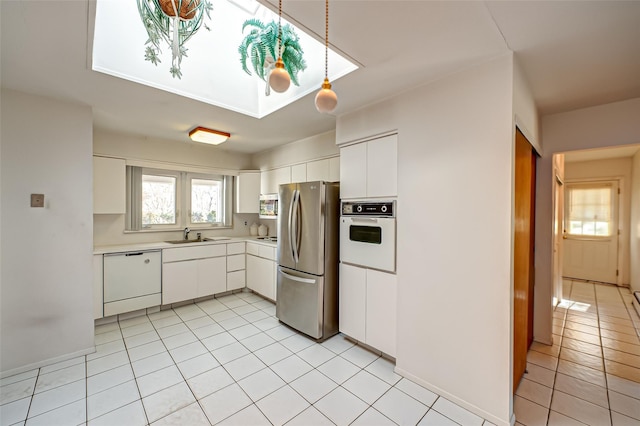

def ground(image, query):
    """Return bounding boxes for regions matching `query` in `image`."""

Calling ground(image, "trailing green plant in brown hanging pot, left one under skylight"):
[138,0,213,78]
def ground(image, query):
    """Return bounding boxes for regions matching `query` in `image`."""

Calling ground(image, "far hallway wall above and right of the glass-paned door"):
[564,158,632,285]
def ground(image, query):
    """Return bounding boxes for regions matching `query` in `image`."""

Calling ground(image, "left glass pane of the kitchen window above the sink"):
[142,174,176,225]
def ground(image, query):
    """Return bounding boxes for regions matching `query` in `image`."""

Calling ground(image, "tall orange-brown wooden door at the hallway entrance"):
[513,129,536,393]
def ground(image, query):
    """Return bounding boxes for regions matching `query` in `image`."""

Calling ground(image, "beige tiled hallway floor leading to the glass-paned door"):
[514,280,640,426]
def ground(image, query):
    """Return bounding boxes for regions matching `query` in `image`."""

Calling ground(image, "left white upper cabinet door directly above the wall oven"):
[340,143,367,198]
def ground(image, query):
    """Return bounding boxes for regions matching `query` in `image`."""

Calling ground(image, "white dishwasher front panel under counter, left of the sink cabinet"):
[104,250,162,304]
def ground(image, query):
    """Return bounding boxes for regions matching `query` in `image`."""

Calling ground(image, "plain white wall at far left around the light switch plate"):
[0,90,94,375]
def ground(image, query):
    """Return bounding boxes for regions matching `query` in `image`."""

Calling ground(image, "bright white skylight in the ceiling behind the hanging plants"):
[93,0,358,118]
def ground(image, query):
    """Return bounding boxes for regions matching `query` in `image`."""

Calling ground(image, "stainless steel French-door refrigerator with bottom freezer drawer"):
[276,181,340,340]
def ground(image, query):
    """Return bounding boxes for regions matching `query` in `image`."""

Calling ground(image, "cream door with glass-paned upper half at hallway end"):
[562,180,619,284]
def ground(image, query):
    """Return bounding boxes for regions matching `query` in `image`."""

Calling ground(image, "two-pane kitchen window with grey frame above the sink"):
[126,166,233,231]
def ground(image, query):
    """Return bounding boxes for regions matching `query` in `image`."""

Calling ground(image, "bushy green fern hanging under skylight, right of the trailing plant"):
[238,19,307,95]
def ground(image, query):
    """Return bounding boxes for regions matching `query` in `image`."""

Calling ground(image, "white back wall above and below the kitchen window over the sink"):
[93,129,258,246]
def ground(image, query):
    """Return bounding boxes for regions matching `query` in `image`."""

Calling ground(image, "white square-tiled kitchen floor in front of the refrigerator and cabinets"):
[0,293,500,426]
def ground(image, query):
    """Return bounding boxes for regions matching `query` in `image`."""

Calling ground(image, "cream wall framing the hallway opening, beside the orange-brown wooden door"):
[534,98,640,343]
